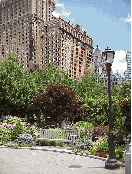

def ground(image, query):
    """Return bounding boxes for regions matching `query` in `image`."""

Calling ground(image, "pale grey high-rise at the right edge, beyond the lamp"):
[124,52,131,82]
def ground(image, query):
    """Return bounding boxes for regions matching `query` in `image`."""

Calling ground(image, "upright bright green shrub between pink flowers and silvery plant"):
[11,120,23,140]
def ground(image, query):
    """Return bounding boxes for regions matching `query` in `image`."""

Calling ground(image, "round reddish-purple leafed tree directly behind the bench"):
[30,84,84,127]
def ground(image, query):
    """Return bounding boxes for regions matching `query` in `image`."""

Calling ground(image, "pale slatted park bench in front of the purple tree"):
[35,128,80,148]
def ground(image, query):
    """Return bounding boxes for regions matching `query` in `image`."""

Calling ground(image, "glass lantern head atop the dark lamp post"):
[102,47,115,65]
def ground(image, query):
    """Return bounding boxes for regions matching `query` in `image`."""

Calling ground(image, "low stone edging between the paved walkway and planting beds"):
[0,146,125,167]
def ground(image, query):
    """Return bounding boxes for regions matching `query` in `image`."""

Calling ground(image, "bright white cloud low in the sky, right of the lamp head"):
[112,50,127,73]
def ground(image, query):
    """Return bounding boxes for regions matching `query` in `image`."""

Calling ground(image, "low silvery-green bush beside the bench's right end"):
[75,137,93,150]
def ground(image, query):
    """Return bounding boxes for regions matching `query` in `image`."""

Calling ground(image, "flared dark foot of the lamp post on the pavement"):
[105,159,120,169]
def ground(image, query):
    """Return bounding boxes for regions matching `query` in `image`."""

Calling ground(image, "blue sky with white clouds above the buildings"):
[55,0,131,75]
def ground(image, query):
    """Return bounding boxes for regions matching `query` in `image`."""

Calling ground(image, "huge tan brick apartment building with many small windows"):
[0,0,94,78]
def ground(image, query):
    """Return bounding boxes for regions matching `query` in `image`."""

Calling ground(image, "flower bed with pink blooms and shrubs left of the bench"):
[0,116,38,147]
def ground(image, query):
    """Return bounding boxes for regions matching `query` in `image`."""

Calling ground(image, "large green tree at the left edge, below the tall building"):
[0,54,35,116]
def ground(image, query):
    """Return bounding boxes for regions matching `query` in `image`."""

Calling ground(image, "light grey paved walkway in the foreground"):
[0,147,125,174]
